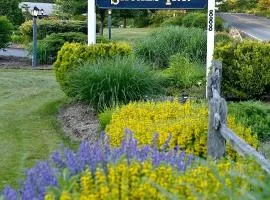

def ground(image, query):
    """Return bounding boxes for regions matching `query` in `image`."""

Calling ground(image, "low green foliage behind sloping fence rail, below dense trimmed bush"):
[229,102,270,141]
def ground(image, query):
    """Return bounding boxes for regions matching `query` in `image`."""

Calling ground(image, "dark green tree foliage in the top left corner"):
[0,0,24,25]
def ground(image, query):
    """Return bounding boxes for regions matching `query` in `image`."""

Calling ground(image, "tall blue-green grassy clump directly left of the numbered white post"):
[135,26,207,67]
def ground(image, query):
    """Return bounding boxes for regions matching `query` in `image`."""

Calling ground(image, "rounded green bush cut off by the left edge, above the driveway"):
[0,16,13,49]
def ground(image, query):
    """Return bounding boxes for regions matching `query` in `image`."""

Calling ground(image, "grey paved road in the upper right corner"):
[219,13,270,41]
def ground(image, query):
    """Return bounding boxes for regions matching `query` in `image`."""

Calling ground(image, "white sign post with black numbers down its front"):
[206,0,216,98]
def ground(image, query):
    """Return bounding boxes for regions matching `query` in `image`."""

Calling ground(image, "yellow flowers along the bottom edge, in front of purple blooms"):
[45,160,264,200]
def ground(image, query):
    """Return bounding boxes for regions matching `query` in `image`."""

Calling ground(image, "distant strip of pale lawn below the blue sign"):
[104,28,154,43]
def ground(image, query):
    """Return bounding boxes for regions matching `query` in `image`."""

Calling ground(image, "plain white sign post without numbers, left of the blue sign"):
[88,0,96,45]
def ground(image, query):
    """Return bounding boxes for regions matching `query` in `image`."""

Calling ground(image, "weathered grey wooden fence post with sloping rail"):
[207,61,270,174]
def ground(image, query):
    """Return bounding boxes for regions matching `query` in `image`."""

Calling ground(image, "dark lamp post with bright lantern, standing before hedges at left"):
[32,6,39,68]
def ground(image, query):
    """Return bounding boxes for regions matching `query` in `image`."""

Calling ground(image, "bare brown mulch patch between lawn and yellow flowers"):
[58,103,100,143]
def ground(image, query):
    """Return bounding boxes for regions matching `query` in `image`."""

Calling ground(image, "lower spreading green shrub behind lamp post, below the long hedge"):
[28,32,87,64]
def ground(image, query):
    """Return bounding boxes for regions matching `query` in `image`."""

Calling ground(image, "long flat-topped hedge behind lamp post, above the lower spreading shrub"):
[19,20,87,43]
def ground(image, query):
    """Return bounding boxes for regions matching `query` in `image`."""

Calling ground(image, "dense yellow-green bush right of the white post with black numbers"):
[215,41,270,99]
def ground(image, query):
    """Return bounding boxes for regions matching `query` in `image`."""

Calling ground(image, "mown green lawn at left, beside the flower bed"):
[0,70,75,190]
